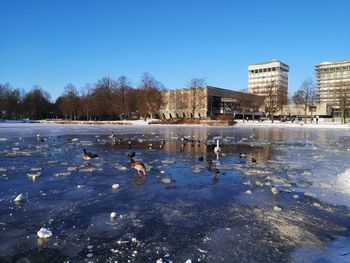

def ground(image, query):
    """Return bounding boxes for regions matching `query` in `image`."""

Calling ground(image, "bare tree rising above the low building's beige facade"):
[188,78,207,118]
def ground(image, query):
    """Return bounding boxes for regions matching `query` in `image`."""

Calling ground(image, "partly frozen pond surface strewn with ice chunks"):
[0,124,350,262]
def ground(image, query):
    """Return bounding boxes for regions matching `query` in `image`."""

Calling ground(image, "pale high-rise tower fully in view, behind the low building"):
[248,60,289,104]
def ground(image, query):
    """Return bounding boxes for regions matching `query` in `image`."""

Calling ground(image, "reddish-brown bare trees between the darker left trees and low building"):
[57,73,164,120]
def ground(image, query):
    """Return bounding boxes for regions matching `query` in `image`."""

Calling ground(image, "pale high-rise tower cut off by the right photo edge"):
[315,60,350,105]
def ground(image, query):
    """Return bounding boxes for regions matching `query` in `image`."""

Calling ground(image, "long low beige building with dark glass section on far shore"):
[160,86,264,119]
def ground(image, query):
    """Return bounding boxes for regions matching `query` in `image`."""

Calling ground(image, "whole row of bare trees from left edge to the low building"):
[0,73,164,120]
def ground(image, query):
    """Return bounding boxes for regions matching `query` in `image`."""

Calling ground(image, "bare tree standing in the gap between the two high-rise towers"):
[292,78,316,123]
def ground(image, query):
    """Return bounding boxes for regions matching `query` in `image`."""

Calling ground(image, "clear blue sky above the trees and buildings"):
[0,0,350,99]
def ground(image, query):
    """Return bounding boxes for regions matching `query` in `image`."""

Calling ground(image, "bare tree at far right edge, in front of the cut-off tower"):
[333,81,350,124]
